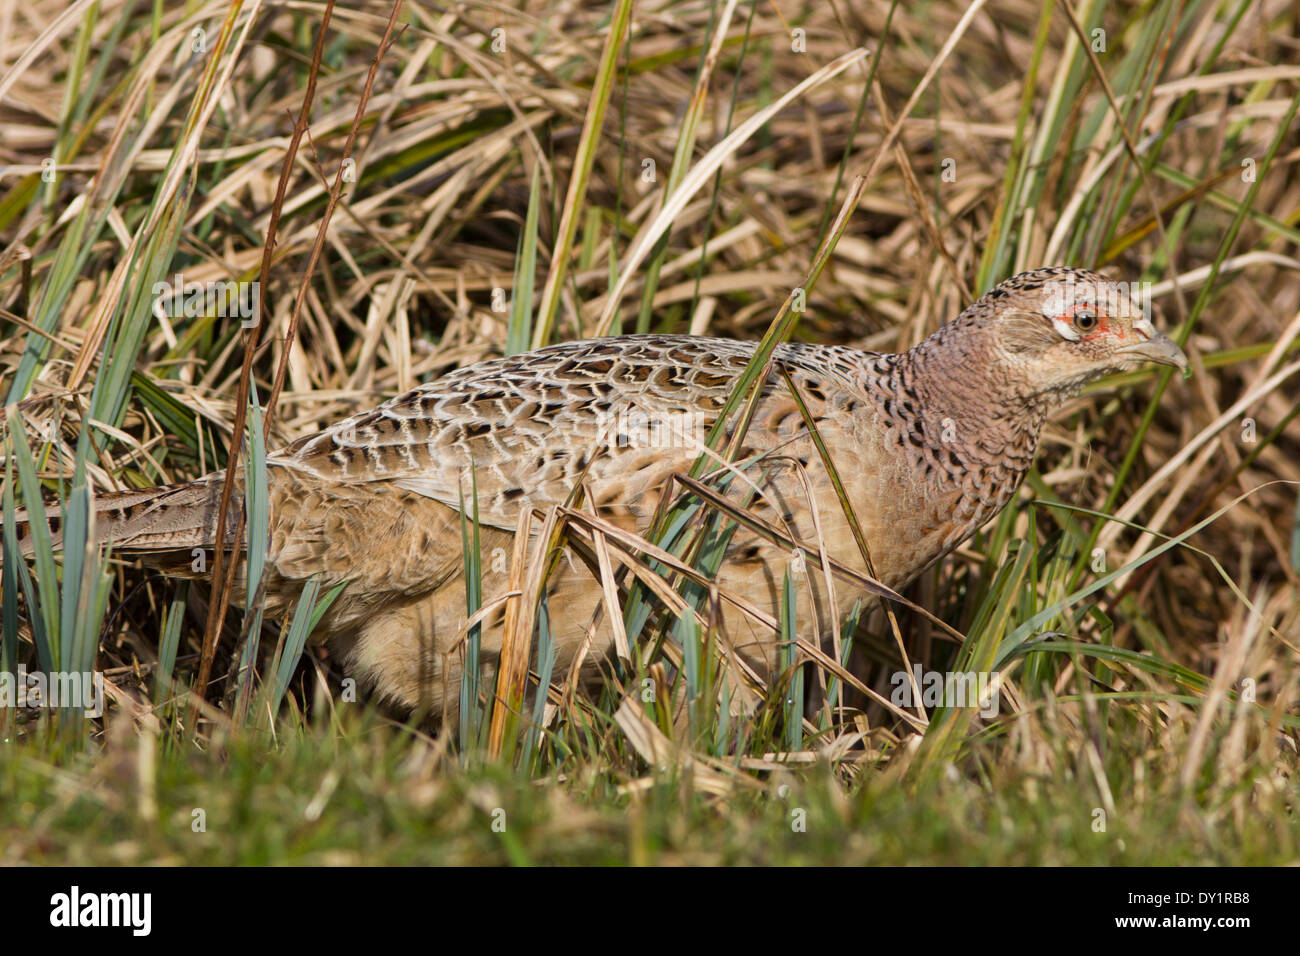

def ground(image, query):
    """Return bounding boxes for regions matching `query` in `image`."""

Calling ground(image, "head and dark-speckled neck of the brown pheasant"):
[868,268,1187,550]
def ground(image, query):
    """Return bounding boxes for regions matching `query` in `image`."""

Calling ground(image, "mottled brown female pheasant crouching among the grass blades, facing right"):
[10,268,1187,719]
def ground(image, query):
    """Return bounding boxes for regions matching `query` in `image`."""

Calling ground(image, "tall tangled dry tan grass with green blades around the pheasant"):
[0,0,1300,860]
